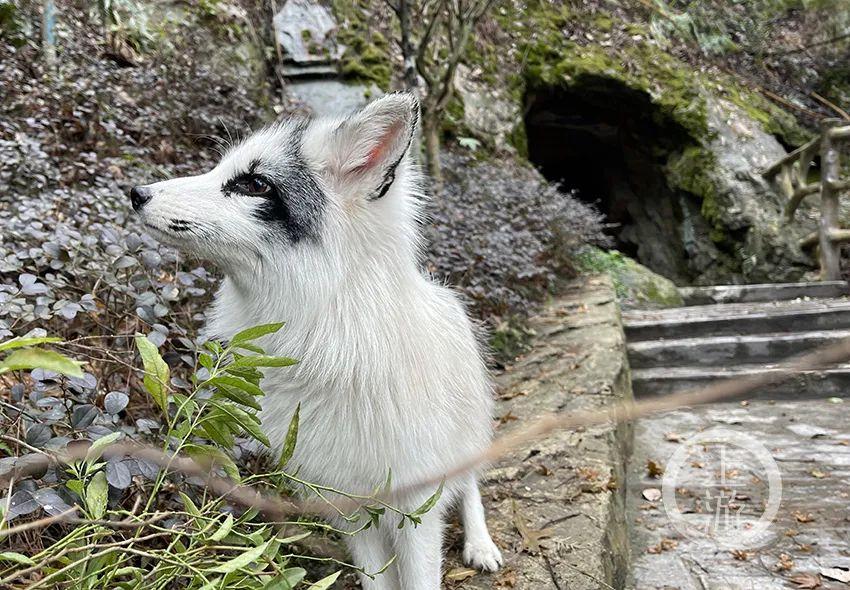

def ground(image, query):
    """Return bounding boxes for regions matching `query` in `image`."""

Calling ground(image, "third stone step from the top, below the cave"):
[628,330,850,369]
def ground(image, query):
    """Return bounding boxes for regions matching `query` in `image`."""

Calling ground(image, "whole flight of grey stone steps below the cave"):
[623,281,850,399]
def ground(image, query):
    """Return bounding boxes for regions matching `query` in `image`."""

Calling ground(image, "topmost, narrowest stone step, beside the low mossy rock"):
[679,281,850,305]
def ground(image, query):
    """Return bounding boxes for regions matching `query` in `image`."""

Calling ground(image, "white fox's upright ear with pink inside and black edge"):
[327,92,419,200]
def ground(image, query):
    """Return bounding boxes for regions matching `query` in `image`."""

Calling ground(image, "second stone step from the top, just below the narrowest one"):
[622,299,850,342]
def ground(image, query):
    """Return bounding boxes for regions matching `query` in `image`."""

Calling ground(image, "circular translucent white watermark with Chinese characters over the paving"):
[661,428,782,549]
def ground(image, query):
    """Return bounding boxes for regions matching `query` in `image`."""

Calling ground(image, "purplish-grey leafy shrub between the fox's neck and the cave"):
[426,153,607,326]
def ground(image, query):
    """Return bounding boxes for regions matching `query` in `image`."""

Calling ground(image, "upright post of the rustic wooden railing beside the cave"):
[818,119,841,281]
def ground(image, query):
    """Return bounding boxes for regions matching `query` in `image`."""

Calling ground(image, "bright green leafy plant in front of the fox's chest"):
[0,324,441,590]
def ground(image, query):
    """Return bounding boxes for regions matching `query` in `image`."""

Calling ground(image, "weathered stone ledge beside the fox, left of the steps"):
[445,277,631,590]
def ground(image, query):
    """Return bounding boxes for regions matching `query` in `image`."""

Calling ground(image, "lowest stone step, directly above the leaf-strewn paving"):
[632,365,850,401]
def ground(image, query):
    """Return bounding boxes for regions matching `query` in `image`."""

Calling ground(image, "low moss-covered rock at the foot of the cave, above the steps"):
[576,246,684,308]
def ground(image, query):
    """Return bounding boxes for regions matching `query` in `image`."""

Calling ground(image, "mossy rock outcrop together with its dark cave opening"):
[448,0,816,284]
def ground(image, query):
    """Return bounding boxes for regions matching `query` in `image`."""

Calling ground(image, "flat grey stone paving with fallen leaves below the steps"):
[627,399,850,590]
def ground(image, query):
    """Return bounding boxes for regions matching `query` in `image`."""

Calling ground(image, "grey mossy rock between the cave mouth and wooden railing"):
[667,96,816,284]
